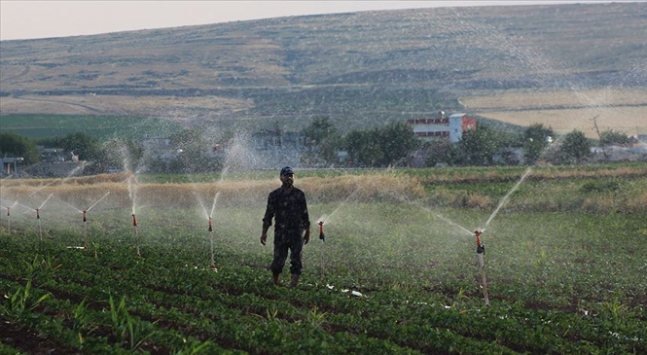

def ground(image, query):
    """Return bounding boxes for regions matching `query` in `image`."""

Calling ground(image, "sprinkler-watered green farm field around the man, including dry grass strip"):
[0,164,647,354]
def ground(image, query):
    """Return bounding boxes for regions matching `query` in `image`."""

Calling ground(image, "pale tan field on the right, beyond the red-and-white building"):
[461,89,647,139]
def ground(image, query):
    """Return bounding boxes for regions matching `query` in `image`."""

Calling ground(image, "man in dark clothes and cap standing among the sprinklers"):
[261,166,310,287]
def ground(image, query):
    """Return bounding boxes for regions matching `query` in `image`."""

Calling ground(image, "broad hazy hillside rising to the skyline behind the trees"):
[0,3,647,135]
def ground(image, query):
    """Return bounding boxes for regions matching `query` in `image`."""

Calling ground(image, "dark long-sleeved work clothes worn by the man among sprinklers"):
[263,187,310,275]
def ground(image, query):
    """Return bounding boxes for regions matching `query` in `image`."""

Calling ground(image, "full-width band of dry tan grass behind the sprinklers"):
[2,166,647,213]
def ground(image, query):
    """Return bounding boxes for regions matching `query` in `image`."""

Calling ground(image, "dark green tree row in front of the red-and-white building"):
[304,117,631,167]
